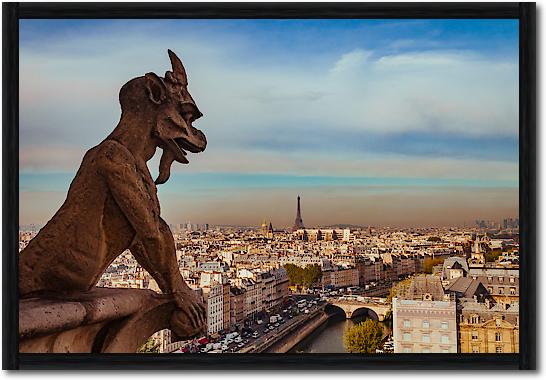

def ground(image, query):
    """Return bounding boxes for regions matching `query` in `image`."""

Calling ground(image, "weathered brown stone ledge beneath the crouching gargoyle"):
[19,288,175,353]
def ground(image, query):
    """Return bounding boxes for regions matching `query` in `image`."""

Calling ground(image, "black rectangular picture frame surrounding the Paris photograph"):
[2,3,536,370]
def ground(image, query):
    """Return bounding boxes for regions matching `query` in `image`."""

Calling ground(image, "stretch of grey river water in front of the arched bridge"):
[289,308,387,353]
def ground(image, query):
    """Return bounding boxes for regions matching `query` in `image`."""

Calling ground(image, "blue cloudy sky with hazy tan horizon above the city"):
[20,20,518,227]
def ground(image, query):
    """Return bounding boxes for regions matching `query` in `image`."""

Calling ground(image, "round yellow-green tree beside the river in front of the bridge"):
[343,319,383,354]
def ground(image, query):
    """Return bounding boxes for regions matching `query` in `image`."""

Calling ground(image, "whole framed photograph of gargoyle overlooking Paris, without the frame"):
[19,19,520,358]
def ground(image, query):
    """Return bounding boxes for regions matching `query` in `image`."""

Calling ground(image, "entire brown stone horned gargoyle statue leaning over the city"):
[19,50,207,338]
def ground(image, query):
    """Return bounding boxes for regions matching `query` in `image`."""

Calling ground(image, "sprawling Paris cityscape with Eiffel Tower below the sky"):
[19,196,519,354]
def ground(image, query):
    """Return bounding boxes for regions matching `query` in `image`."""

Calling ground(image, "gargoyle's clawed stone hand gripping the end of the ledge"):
[171,289,207,338]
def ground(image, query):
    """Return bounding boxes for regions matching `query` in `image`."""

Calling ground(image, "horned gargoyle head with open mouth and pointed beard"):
[120,50,207,184]
